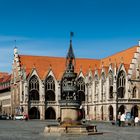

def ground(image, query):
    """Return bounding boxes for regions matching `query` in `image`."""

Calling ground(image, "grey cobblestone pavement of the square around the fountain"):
[0,120,140,140]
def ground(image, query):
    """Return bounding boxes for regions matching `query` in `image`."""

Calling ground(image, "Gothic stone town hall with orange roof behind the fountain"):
[11,40,140,120]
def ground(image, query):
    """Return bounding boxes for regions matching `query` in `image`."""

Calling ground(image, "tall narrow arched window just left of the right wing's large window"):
[109,71,113,98]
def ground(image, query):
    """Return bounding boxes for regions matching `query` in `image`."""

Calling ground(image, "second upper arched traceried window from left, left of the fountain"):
[45,76,55,101]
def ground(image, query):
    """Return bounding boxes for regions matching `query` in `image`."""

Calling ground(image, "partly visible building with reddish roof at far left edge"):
[0,72,11,115]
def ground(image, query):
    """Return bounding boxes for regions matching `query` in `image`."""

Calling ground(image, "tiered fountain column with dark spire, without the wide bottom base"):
[59,33,80,121]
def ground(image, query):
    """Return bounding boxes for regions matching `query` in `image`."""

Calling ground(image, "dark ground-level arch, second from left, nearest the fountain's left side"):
[45,107,56,119]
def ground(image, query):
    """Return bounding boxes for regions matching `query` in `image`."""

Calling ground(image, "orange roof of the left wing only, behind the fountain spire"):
[19,55,100,79]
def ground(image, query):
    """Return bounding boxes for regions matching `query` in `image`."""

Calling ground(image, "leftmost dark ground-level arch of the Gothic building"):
[29,107,40,119]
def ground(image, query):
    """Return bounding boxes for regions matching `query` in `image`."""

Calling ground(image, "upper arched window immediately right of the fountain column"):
[77,77,85,101]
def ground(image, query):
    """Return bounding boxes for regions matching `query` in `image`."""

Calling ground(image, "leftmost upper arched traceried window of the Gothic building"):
[29,75,39,101]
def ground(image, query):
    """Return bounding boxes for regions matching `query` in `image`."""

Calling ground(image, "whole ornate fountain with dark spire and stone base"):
[44,34,102,136]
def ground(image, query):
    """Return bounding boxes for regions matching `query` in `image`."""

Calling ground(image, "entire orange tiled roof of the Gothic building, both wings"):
[19,46,138,80]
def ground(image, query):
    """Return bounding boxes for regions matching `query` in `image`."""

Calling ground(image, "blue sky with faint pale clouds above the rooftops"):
[0,0,140,72]
